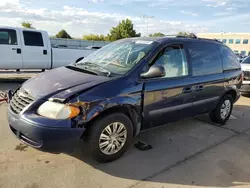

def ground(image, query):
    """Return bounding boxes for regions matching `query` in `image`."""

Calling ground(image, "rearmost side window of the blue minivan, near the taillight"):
[220,46,240,71]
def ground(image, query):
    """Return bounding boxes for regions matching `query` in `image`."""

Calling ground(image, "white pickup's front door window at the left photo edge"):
[0,29,17,45]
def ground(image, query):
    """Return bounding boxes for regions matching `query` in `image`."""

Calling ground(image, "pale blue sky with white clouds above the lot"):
[0,0,250,38]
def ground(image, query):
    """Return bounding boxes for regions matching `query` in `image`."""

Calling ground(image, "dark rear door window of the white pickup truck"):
[23,31,43,46]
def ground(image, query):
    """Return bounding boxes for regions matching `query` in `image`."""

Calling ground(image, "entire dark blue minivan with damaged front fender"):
[8,37,242,162]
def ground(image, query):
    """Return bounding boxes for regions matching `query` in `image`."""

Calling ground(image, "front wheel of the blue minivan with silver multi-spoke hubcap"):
[88,113,133,163]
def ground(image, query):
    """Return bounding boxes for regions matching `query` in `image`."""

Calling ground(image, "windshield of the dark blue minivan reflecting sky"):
[76,39,156,75]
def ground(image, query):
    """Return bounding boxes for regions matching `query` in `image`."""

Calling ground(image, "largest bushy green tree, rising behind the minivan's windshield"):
[107,19,141,41]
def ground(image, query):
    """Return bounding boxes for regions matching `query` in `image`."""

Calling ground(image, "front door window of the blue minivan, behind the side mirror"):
[153,45,188,78]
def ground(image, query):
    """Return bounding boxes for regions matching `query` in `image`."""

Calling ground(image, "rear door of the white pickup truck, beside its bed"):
[22,30,51,69]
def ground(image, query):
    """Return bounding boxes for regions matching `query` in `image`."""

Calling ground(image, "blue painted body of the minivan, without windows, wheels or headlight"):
[8,38,242,153]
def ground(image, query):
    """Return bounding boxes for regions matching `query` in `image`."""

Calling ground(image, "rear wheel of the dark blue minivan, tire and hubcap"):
[209,94,233,126]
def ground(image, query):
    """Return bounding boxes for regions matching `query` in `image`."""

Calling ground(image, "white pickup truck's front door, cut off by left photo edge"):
[0,28,23,69]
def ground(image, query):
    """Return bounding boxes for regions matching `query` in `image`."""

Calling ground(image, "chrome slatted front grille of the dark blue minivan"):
[10,89,34,114]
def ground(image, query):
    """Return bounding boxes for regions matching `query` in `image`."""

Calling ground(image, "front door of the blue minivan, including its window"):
[143,44,193,129]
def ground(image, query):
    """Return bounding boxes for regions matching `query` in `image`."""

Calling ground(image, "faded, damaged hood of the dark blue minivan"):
[22,67,110,99]
